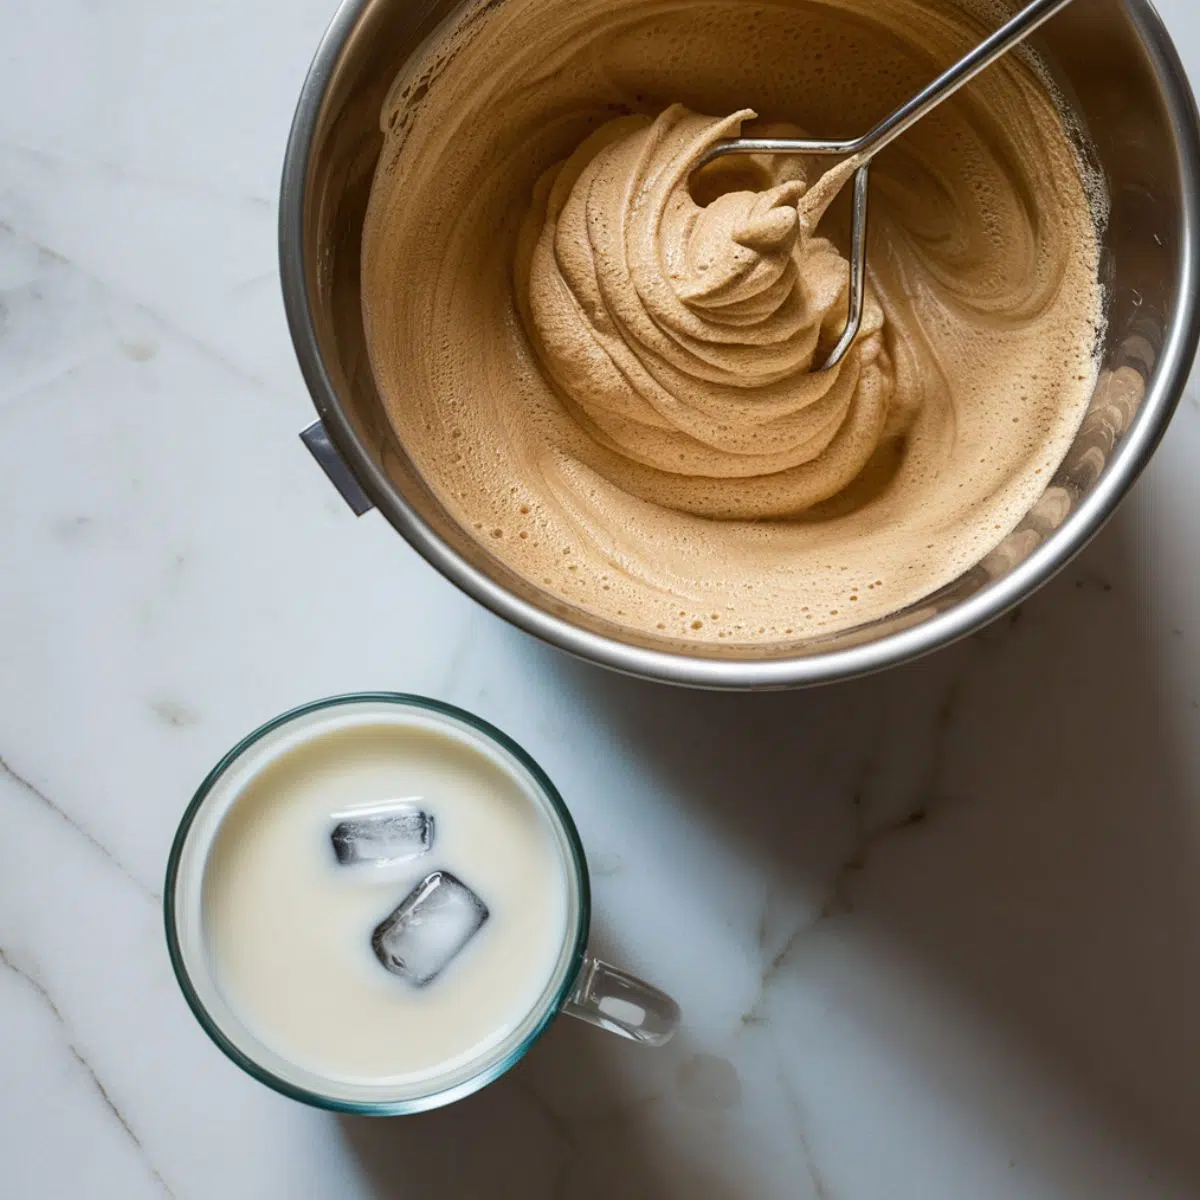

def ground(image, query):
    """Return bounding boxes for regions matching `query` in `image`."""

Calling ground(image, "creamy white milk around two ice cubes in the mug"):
[203,709,574,1088]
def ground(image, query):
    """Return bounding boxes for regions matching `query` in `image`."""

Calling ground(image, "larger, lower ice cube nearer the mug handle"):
[371,871,488,988]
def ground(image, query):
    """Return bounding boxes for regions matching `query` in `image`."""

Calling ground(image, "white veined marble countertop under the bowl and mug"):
[0,0,1200,1200]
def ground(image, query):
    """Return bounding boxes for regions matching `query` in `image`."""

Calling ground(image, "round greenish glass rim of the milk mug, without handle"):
[163,691,592,1116]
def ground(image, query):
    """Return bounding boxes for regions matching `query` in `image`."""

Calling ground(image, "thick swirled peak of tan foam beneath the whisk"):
[518,104,894,518]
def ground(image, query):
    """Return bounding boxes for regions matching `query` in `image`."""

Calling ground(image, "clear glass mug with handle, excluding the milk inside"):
[163,692,679,1116]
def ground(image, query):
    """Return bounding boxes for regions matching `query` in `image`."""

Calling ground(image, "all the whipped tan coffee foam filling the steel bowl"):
[362,0,1102,644]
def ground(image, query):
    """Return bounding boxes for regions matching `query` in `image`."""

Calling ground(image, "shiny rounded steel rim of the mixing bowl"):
[278,0,1200,690]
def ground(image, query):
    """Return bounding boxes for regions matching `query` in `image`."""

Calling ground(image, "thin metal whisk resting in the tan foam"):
[696,0,1072,371]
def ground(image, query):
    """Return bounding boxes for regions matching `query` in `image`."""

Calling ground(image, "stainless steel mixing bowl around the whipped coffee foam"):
[280,0,1200,689]
